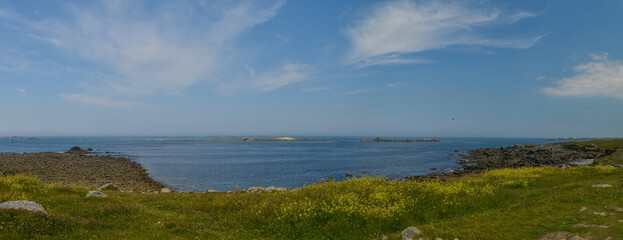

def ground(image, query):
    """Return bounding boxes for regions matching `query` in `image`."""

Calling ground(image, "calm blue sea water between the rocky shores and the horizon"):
[0,136,550,191]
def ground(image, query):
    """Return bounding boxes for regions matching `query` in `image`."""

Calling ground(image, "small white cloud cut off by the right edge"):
[542,53,623,98]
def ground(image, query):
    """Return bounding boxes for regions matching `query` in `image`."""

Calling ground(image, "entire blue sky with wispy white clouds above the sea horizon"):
[0,0,623,138]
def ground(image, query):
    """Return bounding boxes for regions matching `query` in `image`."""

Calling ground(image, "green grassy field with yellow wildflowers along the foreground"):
[0,140,623,239]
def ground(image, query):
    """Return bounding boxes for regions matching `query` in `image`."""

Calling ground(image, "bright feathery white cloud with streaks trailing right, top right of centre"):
[347,0,540,66]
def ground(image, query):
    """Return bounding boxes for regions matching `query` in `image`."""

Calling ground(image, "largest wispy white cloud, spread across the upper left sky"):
[0,0,286,105]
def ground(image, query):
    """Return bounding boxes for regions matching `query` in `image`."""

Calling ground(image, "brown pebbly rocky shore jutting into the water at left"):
[0,149,164,192]
